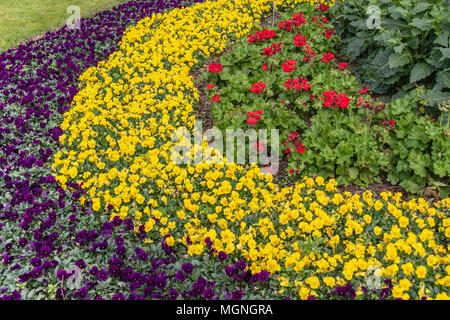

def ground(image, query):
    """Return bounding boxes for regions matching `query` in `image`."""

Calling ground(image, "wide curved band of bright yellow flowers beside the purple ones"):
[54,0,450,299]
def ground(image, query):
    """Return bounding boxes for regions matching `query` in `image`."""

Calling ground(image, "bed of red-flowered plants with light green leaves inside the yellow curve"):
[206,4,450,198]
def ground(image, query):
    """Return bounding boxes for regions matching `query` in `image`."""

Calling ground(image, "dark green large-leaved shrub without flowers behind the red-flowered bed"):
[333,0,450,106]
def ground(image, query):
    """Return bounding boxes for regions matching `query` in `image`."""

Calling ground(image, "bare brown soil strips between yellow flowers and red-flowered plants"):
[191,14,440,201]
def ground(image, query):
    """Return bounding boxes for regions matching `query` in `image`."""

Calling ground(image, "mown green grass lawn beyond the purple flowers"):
[0,0,129,52]
